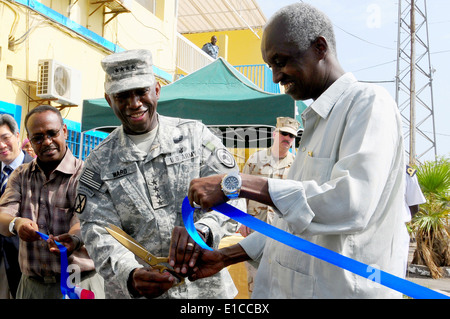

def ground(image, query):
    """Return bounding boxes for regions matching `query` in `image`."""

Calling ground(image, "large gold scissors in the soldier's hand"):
[105,224,184,287]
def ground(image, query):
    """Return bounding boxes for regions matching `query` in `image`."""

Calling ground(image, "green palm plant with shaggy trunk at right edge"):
[410,158,450,278]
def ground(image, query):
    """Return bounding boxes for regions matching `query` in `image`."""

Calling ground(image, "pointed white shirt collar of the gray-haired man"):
[311,72,357,119]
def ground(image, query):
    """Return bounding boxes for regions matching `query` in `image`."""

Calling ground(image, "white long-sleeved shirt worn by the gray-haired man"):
[241,73,408,298]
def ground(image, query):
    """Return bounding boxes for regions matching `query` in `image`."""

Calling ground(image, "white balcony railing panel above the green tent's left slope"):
[177,33,215,74]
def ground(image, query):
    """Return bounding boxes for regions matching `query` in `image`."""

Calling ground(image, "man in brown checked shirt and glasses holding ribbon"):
[0,105,103,299]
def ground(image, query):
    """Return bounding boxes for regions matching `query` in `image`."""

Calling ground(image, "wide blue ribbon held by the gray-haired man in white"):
[182,197,450,299]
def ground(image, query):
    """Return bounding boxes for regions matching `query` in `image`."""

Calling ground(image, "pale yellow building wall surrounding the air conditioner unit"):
[0,0,176,141]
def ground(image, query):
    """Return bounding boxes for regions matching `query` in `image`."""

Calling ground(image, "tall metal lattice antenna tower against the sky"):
[395,0,437,165]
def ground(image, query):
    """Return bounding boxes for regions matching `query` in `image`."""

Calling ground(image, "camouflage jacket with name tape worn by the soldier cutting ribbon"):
[77,115,245,298]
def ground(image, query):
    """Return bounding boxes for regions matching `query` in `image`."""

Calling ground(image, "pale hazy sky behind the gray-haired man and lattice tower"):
[257,0,450,162]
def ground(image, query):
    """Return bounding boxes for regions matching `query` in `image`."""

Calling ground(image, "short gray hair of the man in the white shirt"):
[266,3,336,56]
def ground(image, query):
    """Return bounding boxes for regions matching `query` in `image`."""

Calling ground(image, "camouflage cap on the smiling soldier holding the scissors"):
[102,50,155,94]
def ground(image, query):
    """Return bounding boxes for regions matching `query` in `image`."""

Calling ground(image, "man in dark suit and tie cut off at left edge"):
[0,114,33,299]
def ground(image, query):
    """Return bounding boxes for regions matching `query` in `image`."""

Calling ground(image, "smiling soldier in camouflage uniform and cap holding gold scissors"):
[77,50,245,298]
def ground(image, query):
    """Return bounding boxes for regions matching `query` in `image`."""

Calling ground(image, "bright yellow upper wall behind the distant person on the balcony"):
[183,29,264,65]
